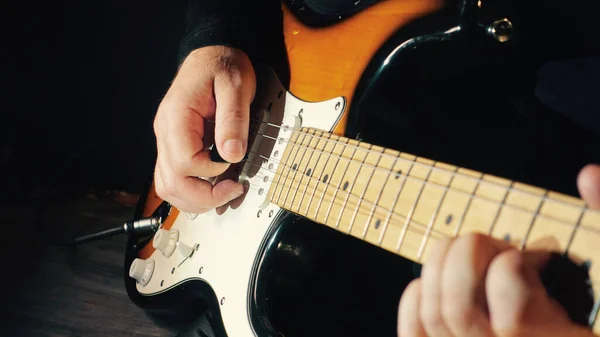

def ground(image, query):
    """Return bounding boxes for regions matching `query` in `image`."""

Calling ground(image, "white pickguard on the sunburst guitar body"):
[137,70,346,337]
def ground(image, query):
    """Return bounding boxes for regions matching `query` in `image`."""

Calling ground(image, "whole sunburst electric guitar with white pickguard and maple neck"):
[125,0,600,337]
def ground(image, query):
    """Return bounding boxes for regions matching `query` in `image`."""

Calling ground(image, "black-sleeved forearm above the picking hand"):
[179,0,283,61]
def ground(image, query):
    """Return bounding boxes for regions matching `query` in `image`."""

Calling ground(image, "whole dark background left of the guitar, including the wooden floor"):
[0,0,185,337]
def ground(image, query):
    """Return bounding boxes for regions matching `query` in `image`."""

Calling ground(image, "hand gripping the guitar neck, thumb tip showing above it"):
[398,165,600,337]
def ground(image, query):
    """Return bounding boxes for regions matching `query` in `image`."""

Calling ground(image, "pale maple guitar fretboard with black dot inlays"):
[269,129,600,333]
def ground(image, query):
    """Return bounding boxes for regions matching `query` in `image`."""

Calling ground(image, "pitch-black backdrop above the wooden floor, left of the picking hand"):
[0,0,185,200]
